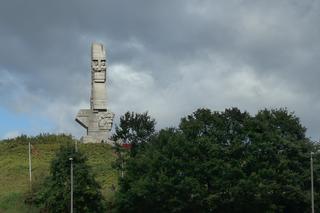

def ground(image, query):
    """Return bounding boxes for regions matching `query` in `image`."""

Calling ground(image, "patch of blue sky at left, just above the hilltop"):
[0,106,54,139]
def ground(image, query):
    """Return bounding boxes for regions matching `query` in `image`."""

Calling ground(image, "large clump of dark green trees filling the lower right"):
[115,108,319,212]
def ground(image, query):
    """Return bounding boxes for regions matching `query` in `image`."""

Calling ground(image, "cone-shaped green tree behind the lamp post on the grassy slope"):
[37,144,105,212]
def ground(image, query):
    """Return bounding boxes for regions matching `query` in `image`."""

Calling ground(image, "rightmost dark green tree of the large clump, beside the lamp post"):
[243,109,312,212]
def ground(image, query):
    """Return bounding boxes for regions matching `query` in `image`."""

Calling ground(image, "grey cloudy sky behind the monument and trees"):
[0,0,320,140]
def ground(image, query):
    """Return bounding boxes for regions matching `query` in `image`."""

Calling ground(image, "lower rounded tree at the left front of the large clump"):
[115,129,204,212]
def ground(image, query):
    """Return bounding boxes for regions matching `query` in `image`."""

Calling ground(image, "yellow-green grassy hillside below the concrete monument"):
[0,134,117,213]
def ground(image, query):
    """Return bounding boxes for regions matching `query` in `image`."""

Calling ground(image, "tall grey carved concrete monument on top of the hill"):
[76,43,114,143]
